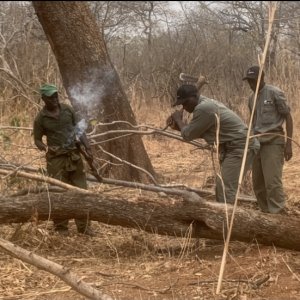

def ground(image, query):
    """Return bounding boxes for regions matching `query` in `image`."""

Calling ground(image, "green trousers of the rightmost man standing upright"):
[252,143,285,214]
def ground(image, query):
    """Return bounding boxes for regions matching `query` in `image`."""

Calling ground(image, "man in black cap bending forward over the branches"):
[167,84,259,203]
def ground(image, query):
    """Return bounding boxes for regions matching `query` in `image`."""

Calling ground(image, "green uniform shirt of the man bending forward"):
[181,96,259,148]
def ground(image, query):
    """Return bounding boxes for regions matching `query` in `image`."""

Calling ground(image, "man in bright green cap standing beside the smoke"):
[33,84,95,236]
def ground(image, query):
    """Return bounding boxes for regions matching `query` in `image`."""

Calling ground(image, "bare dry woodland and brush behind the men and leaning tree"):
[0,1,300,122]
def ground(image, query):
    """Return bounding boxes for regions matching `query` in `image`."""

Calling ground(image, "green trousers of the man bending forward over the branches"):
[216,148,257,204]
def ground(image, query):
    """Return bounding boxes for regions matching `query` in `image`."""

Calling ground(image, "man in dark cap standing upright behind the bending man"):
[243,66,293,214]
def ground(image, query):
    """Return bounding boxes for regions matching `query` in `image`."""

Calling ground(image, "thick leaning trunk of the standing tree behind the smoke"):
[32,1,154,182]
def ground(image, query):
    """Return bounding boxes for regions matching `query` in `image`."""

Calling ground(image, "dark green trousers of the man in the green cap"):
[47,150,90,233]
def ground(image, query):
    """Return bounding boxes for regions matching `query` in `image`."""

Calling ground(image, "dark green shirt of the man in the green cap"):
[33,103,76,150]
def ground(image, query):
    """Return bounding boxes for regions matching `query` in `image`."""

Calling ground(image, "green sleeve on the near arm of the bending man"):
[181,109,215,141]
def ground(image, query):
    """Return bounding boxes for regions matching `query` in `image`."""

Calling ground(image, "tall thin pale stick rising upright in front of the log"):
[216,2,277,294]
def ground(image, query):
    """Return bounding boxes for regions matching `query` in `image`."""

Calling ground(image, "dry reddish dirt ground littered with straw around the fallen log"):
[0,109,300,300]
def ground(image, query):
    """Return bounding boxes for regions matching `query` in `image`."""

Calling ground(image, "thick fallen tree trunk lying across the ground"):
[0,192,300,250]
